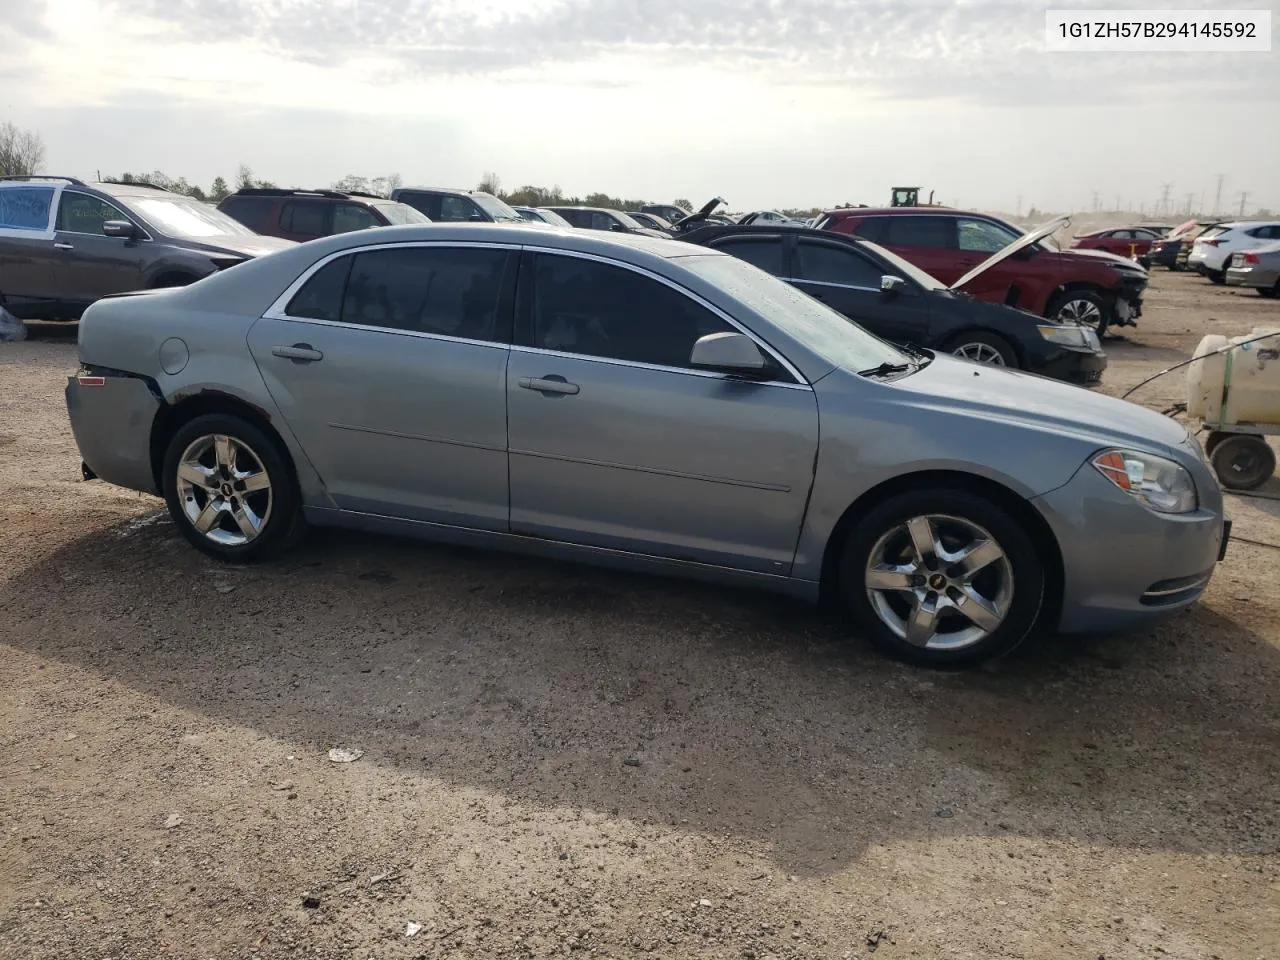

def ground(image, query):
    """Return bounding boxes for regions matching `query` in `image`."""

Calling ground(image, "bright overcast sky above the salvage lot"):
[0,0,1280,212]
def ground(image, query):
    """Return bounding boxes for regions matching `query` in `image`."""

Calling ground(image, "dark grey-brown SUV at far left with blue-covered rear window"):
[0,177,293,320]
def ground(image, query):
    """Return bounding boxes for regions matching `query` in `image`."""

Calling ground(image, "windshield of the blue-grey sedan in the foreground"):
[680,255,911,371]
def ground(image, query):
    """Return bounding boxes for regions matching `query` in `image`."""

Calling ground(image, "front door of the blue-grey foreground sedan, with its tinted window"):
[507,253,818,576]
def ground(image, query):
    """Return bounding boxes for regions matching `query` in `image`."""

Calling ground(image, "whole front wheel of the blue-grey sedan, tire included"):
[840,488,1044,667]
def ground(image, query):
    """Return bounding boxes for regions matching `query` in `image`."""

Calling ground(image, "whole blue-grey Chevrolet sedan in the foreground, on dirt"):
[67,224,1226,664]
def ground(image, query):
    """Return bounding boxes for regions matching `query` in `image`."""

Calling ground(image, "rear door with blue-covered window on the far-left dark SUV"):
[0,183,61,319]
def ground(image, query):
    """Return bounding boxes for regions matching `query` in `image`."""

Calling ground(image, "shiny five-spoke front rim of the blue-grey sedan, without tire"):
[865,515,1014,650]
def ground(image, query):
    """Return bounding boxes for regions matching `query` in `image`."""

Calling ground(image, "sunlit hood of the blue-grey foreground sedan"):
[892,355,1187,456]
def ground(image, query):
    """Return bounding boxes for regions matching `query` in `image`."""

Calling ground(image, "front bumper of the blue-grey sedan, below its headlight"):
[1032,462,1226,634]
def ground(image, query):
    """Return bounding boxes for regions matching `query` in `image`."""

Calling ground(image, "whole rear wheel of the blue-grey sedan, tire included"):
[161,413,305,563]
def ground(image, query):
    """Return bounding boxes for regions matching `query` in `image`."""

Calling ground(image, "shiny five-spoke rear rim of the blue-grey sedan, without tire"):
[178,434,274,547]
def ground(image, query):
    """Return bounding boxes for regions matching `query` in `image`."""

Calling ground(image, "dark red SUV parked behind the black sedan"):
[817,206,1147,335]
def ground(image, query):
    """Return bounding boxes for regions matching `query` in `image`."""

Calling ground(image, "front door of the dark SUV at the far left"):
[54,189,146,305]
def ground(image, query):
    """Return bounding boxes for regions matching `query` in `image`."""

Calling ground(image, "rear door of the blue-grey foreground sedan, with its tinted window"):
[248,243,517,531]
